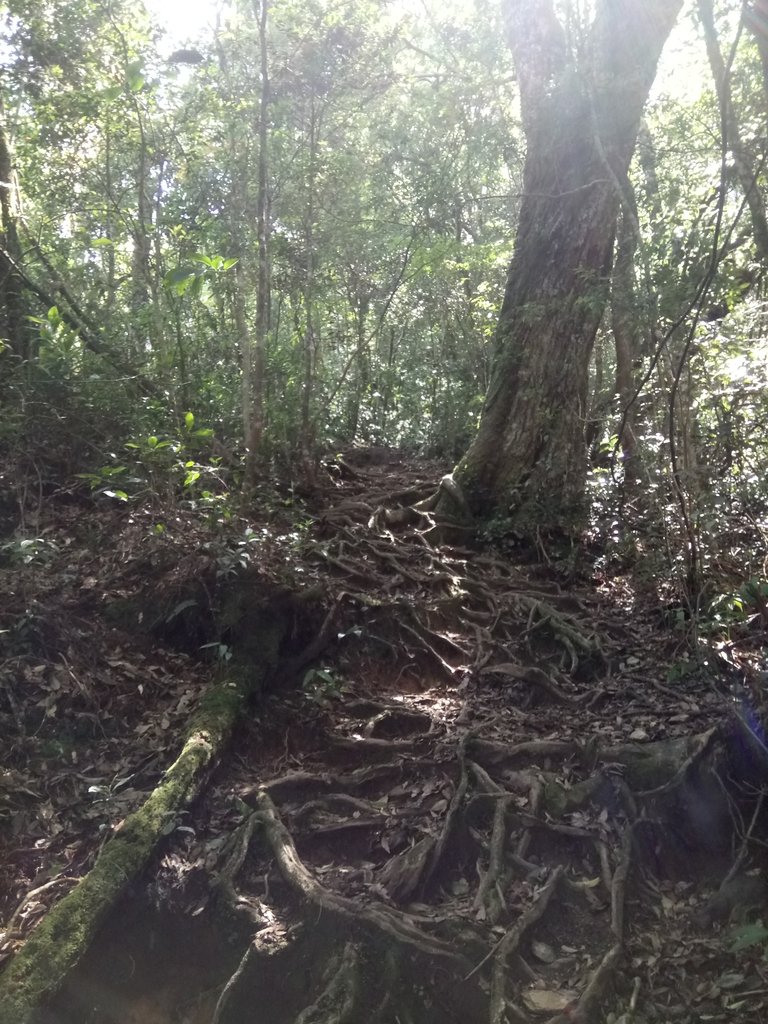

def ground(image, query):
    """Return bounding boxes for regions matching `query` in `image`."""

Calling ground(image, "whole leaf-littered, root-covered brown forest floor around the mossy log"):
[0,450,768,1024]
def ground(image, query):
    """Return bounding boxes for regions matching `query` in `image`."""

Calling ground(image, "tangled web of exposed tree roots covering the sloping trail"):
[10,456,768,1024]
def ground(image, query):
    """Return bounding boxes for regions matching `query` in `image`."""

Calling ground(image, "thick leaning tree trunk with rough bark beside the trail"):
[456,0,682,532]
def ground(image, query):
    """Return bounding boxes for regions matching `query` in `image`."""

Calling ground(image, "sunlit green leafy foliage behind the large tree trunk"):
[0,0,768,614]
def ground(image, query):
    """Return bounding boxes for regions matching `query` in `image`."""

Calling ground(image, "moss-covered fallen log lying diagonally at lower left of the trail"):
[0,622,282,1024]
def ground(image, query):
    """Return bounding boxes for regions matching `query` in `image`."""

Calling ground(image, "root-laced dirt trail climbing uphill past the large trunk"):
[1,450,768,1024]
